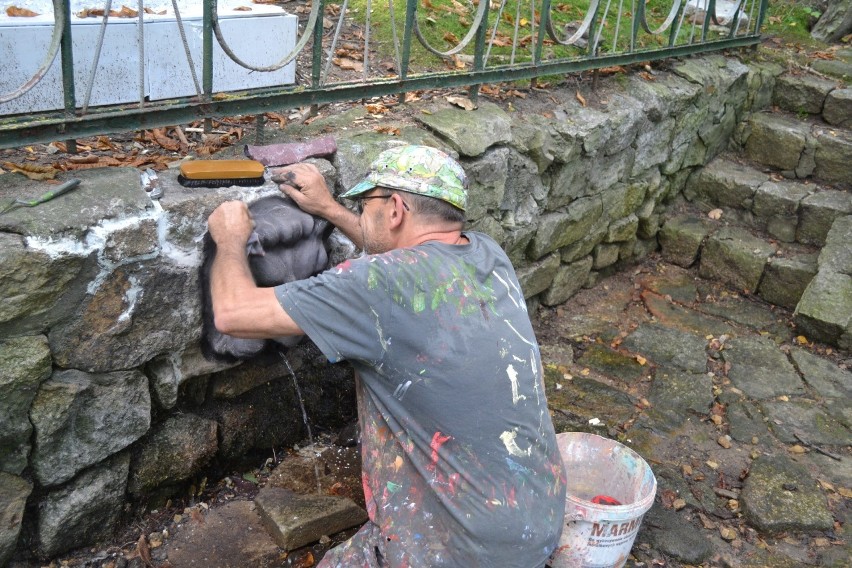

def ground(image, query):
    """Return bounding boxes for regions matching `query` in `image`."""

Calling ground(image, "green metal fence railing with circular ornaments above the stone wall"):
[0,0,768,148]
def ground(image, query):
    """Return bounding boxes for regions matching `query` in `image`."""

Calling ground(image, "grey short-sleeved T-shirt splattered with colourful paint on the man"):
[276,232,565,568]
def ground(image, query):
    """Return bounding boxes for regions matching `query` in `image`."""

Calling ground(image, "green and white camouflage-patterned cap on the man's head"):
[341,145,467,211]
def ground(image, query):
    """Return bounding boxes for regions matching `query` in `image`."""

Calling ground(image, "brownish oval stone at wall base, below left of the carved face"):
[127,414,218,496]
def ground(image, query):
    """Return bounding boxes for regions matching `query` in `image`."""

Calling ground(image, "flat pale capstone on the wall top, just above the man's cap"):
[417,102,512,157]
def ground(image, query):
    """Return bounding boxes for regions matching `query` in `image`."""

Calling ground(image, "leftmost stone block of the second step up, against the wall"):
[684,159,769,210]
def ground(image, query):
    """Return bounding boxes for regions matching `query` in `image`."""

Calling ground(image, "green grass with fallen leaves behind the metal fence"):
[336,0,768,70]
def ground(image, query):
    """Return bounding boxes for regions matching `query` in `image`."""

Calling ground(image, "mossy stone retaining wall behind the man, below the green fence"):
[0,56,781,565]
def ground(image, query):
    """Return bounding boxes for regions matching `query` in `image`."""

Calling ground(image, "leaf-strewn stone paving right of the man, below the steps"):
[537,256,852,567]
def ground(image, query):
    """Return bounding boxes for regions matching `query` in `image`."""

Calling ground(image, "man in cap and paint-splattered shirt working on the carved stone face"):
[209,146,565,568]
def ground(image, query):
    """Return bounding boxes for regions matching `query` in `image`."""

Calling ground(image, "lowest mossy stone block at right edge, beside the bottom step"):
[794,270,852,345]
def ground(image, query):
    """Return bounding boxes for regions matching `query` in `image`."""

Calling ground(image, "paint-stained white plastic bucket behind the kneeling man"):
[550,432,657,568]
